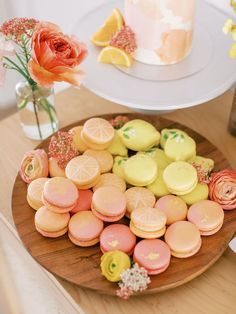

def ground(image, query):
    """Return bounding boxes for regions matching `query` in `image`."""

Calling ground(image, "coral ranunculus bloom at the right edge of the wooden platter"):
[209,169,236,210]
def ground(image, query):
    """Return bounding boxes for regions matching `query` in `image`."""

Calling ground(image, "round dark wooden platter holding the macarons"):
[12,114,236,295]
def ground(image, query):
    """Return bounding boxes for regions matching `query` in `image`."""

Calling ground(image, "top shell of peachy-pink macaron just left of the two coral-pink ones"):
[69,211,103,241]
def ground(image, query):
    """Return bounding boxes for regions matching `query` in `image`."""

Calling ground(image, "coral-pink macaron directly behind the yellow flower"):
[100,224,136,255]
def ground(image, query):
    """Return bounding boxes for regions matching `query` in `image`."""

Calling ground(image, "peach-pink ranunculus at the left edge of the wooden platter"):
[20,149,48,183]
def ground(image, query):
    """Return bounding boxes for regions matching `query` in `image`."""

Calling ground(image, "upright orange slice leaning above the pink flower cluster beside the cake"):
[91,9,124,47]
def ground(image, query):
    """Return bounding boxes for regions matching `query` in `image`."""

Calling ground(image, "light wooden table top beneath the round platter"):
[0,88,236,314]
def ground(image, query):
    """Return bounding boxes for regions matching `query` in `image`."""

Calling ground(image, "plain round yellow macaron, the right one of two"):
[163,161,198,195]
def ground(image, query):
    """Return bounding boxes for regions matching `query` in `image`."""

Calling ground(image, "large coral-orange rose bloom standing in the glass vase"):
[28,22,87,87]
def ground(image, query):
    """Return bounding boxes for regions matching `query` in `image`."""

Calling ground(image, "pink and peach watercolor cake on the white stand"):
[125,0,196,65]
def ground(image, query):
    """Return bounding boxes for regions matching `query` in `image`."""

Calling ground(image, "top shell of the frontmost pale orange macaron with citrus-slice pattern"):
[131,207,167,232]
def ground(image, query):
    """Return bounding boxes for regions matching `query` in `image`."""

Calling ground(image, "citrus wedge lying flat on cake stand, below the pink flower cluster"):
[98,46,133,67]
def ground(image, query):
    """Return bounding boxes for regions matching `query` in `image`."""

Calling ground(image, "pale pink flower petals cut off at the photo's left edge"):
[0,33,15,86]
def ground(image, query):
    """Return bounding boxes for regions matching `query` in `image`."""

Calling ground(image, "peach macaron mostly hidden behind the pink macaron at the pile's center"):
[93,173,126,192]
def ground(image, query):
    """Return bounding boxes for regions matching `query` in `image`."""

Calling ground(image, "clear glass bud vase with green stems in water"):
[16,81,58,140]
